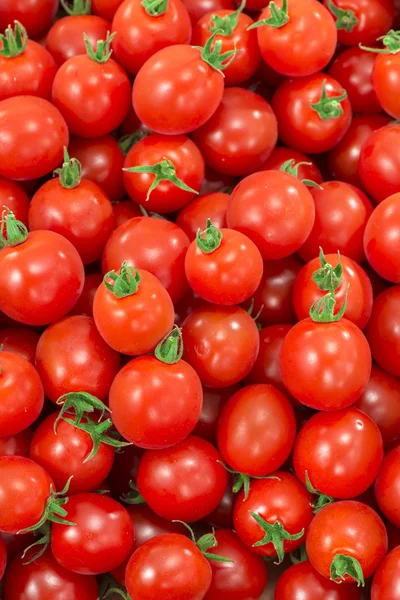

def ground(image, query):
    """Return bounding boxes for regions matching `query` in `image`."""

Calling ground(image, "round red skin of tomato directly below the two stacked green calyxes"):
[281,318,371,410]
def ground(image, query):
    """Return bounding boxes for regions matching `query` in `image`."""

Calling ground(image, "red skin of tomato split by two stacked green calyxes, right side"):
[293,254,373,329]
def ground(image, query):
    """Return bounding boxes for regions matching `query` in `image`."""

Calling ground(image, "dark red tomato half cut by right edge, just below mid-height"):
[365,285,400,377]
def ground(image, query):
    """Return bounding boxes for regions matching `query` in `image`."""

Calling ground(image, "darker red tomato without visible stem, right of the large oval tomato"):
[193,87,278,175]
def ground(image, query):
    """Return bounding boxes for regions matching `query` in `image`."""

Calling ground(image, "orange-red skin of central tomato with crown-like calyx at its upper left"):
[93,269,174,356]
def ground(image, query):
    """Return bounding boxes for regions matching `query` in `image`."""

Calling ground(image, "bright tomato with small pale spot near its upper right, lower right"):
[293,407,383,499]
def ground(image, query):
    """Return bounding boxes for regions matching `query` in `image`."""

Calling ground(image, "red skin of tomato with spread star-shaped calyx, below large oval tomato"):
[124,134,204,214]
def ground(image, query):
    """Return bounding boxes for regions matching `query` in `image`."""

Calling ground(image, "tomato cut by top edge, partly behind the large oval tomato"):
[112,0,192,75]
